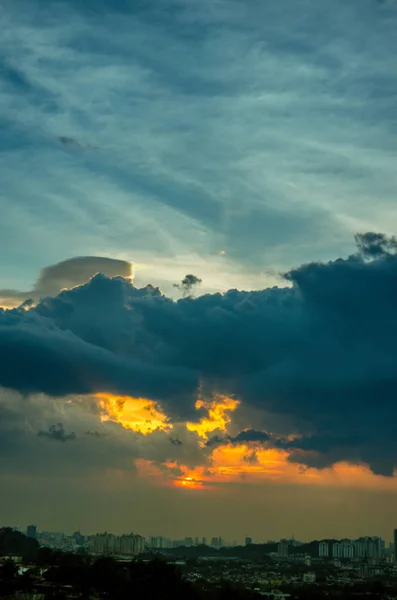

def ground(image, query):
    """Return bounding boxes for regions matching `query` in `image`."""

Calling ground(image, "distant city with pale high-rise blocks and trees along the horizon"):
[0,524,397,600]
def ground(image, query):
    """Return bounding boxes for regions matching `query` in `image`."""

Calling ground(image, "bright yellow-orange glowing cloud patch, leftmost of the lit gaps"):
[96,394,172,435]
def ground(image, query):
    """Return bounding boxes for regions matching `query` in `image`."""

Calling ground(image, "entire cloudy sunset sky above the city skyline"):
[0,0,397,541]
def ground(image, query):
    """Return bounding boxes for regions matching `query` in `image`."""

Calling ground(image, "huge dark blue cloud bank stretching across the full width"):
[0,233,397,475]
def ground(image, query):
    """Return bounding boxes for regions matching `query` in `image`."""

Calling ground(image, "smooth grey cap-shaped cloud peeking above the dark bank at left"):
[0,256,133,306]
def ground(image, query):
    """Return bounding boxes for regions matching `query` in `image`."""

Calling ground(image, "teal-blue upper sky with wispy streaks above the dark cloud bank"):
[0,0,397,291]
